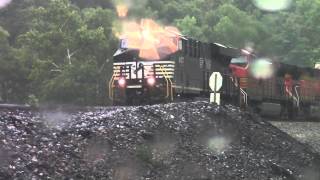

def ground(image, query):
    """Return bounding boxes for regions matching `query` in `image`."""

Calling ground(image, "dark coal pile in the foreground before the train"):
[0,102,320,180]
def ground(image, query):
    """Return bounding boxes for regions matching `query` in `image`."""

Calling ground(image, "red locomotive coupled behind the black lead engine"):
[229,56,320,118]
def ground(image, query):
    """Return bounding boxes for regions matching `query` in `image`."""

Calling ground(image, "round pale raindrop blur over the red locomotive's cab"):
[250,58,274,79]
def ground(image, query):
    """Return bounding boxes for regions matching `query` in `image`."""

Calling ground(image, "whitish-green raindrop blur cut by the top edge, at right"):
[253,0,292,11]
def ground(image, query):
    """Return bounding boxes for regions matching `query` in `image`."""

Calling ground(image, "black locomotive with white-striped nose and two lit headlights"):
[109,38,249,105]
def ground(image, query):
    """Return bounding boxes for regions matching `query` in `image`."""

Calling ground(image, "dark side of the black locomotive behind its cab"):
[175,39,240,97]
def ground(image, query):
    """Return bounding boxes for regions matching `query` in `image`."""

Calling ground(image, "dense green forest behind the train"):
[0,0,320,105]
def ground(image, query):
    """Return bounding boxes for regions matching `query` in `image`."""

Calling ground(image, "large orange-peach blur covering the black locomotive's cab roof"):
[120,19,180,60]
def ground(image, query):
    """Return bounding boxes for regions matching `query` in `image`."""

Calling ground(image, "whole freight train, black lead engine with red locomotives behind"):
[108,37,320,118]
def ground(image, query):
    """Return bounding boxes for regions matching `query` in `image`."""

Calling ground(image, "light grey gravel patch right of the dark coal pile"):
[271,122,320,153]
